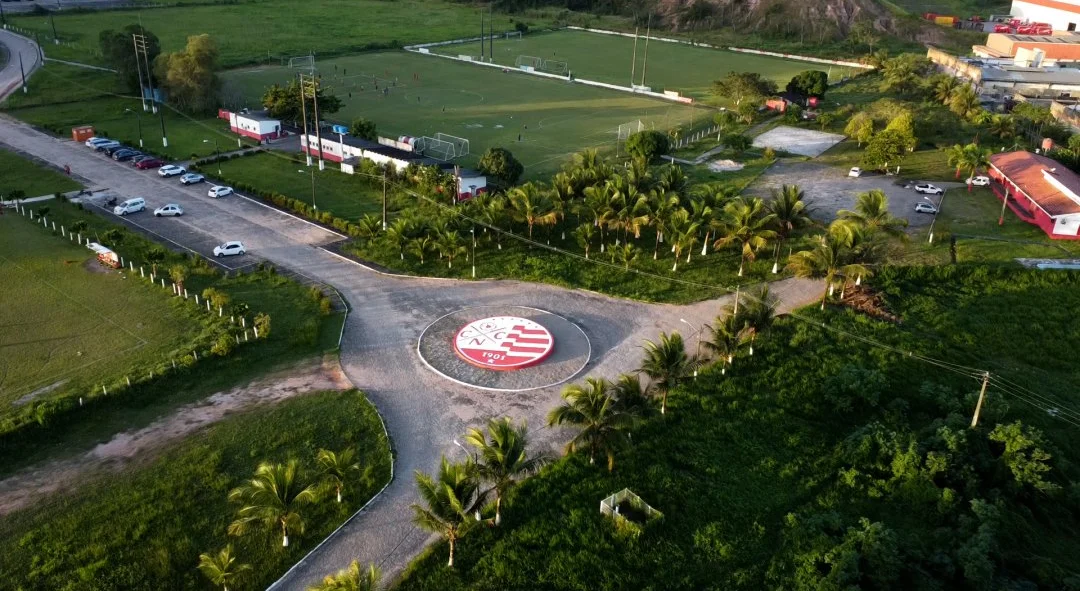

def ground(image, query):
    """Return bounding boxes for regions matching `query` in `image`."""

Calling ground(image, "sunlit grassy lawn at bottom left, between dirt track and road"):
[0,390,391,591]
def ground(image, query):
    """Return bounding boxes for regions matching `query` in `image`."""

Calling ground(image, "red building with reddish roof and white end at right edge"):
[989,151,1080,240]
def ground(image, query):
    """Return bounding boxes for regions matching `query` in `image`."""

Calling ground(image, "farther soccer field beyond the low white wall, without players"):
[431,30,848,102]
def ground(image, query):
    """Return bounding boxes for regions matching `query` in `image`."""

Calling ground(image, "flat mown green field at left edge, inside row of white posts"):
[0,213,203,419]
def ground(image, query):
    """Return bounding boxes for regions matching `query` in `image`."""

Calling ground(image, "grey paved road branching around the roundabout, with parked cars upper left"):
[0,116,821,590]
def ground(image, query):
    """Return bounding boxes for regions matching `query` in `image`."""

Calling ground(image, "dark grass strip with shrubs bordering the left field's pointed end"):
[0,202,343,474]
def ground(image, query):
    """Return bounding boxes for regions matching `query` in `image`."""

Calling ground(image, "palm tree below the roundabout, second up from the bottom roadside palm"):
[465,418,548,525]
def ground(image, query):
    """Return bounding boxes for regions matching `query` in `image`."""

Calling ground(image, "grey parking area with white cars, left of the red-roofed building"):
[746,160,964,228]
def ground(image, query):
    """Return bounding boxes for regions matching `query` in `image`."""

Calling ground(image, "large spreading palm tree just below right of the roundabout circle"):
[548,377,634,472]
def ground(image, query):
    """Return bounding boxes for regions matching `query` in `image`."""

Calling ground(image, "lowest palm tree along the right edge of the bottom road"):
[413,456,484,567]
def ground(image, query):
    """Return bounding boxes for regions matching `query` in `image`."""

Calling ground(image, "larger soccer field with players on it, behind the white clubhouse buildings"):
[225,52,712,177]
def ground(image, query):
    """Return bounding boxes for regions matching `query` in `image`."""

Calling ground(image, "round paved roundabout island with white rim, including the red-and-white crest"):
[417,306,592,392]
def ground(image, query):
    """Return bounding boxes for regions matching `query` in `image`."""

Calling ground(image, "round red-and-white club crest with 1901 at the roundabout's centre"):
[454,317,555,371]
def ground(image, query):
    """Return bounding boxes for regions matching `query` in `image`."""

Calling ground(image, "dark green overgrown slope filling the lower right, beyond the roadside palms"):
[397,267,1080,591]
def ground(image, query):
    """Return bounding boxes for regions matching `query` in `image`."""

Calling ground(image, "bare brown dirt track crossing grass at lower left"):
[0,358,353,515]
